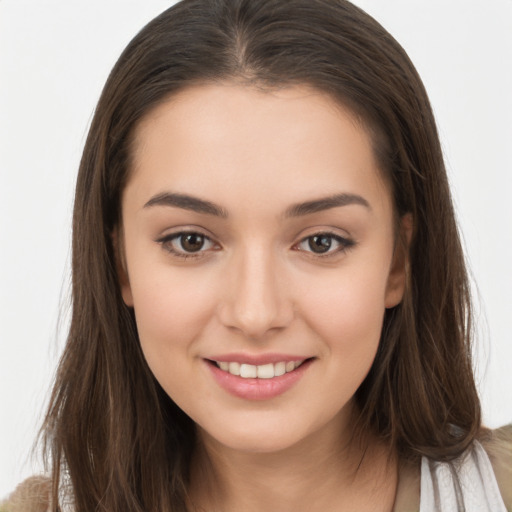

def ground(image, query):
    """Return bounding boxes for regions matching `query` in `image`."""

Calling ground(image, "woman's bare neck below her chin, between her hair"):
[190,414,397,512]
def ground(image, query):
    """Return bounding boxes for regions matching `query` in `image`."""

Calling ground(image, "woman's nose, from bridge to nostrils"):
[218,245,294,340]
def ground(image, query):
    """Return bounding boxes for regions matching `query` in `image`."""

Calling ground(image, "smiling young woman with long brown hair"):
[3,0,511,512]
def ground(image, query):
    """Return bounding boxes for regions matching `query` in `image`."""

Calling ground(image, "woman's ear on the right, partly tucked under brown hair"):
[385,213,413,309]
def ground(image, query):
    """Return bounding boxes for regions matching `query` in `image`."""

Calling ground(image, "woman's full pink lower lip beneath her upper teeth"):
[207,359,313,400]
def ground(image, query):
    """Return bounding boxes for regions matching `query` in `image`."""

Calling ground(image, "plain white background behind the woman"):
[0,0,512,497]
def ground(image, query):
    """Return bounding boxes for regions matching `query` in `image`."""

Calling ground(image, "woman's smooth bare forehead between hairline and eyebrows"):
[128,84,389,214]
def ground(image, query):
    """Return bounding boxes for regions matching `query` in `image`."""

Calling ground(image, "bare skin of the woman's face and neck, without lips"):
[117,83,410,512]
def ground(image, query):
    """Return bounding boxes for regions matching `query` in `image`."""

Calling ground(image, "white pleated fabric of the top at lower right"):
[420,441,507,512]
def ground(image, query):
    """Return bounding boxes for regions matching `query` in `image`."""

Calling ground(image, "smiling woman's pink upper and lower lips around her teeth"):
[205,354,314,401]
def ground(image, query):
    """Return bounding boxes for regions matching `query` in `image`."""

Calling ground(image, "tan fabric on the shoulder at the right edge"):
[480,424,512,511]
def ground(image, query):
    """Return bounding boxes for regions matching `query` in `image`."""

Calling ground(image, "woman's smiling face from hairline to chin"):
[119,84,404,452]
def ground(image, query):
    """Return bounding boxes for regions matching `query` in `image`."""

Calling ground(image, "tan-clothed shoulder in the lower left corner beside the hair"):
[0,476,51,512]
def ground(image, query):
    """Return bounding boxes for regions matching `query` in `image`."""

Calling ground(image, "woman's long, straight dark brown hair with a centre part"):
[45,0,480,512]
